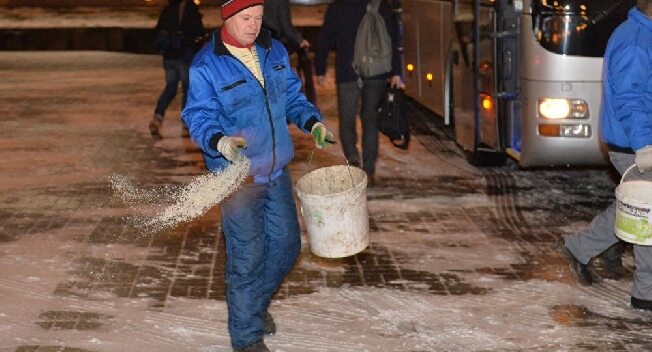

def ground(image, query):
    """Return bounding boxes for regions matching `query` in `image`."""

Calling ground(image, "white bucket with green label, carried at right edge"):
[614,164,652,246]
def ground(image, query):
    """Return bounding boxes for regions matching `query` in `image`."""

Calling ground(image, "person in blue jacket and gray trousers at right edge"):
[564,0,652,311]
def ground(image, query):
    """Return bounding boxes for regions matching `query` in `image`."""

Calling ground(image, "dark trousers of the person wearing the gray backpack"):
[337,79,386,176]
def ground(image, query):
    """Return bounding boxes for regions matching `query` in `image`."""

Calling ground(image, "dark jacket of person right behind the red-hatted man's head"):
[263,0,303,49]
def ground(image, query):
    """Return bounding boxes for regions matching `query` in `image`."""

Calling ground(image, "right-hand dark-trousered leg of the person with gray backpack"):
[361,79,386,177]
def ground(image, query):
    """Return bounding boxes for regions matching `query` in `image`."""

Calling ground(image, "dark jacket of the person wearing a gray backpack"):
[315,0,402,83]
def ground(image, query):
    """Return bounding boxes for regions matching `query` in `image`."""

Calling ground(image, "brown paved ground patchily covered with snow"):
[0,52,652,352]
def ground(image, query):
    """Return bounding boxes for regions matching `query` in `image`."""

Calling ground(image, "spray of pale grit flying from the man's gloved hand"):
[110,156,251,232]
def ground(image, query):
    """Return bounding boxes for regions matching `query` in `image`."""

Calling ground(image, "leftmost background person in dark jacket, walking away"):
[149,0,204,137]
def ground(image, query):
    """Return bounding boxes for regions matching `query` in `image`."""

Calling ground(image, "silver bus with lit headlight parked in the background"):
[402,0,636,168]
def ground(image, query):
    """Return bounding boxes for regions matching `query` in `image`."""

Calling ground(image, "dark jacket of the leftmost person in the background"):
[154,0,204,62]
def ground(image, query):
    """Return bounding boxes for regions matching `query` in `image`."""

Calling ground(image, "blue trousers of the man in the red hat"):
[221,170,301,349]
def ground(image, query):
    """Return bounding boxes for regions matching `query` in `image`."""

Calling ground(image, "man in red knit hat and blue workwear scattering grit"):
[182,0,333,352]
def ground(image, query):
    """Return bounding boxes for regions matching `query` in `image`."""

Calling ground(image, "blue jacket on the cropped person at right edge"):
[600,8,652,151]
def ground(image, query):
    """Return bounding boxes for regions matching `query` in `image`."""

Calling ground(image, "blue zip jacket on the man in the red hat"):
[182,29,321,183]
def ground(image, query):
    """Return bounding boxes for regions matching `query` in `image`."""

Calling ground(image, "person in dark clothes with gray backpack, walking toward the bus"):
[315,0,404,186]
